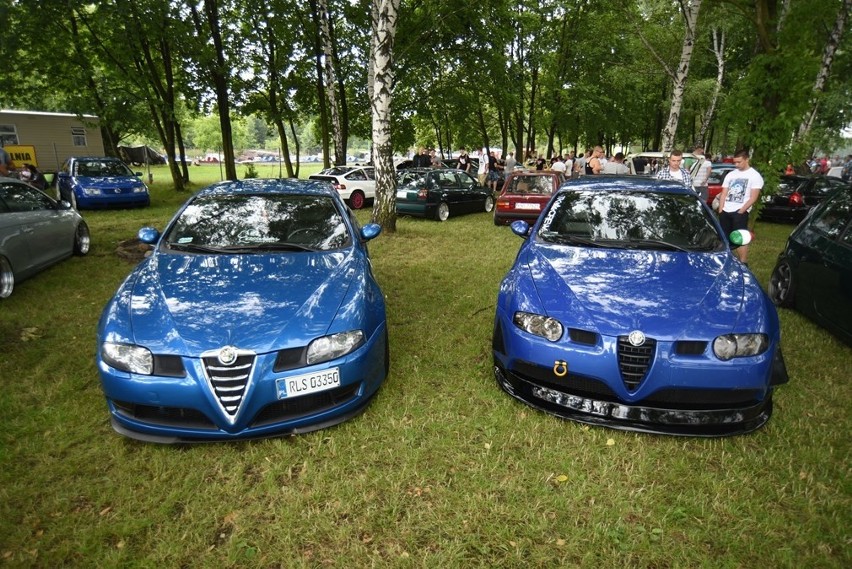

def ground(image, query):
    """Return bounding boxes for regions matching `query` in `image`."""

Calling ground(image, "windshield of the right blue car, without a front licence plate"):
[538,190,724,251]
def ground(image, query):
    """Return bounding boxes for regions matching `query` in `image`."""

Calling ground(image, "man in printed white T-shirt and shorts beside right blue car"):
[719,150,763,263]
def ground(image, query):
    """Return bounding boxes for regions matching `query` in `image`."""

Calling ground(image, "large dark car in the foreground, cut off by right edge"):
[769,186,852,345]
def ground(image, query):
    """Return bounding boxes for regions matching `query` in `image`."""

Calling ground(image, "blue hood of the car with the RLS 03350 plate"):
[119,248,352,354]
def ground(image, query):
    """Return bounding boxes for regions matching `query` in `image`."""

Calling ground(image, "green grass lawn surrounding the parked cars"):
[0,166,852,568]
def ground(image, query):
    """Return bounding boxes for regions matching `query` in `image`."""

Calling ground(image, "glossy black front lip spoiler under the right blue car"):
[494,365,772,437]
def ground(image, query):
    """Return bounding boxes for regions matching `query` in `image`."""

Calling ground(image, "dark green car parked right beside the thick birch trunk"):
[396,168,494,221]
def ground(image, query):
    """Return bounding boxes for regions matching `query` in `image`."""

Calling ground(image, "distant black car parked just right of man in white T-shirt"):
[760,176,849,223]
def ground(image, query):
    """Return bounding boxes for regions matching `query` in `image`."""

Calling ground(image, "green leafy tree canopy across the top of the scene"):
[0,0,852,187]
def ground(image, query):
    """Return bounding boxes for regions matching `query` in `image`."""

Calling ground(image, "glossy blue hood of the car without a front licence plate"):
[519,245,765,339]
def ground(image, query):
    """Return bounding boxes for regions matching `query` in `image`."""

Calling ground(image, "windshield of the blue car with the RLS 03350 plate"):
[164,194,350,252]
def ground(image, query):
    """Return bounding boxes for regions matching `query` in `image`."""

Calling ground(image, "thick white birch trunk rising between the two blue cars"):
[370,0,400,233]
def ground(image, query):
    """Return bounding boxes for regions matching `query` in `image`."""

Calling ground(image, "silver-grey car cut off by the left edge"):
[0,177,91,298]
